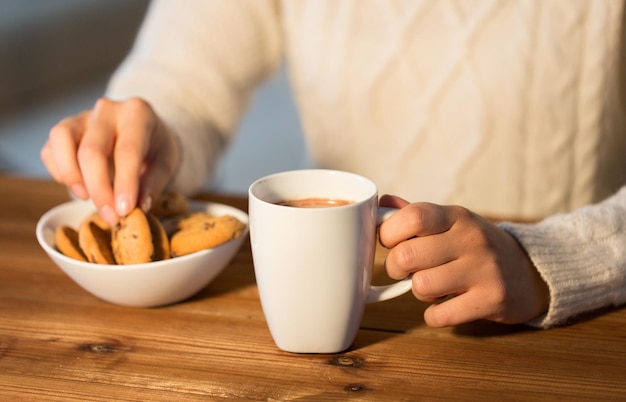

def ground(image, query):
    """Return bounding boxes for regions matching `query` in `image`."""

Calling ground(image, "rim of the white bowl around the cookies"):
[35,199,250,270]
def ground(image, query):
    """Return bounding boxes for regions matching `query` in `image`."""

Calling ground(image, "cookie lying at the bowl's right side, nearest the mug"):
[170,214,246,257]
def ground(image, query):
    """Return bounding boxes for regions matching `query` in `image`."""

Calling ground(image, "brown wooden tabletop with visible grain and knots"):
[0,176,626,401]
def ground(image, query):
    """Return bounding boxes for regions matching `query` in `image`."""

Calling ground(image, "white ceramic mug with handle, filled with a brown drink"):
[248,169,411,353]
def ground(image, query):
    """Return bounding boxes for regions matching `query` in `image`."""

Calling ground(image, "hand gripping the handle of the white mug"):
[380,196,549,327]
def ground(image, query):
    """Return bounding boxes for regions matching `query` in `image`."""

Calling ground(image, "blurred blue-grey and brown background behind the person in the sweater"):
[0,0,310,193]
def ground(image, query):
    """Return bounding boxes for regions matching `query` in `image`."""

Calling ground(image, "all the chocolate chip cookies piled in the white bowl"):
[55,192,246,265]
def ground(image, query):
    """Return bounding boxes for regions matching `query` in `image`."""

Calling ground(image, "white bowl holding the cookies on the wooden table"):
[36,201,248,307]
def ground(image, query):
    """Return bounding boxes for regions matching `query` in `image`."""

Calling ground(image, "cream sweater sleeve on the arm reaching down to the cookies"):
[106,0,282,194]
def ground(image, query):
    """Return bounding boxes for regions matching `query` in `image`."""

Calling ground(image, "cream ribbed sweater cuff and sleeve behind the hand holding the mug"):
[500,186,626,328]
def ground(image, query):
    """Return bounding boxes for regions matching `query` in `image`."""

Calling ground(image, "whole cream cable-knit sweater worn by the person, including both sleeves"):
[107,0,626,327]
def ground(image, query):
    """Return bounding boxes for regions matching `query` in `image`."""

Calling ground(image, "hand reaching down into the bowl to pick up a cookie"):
[41,98,180,224]
